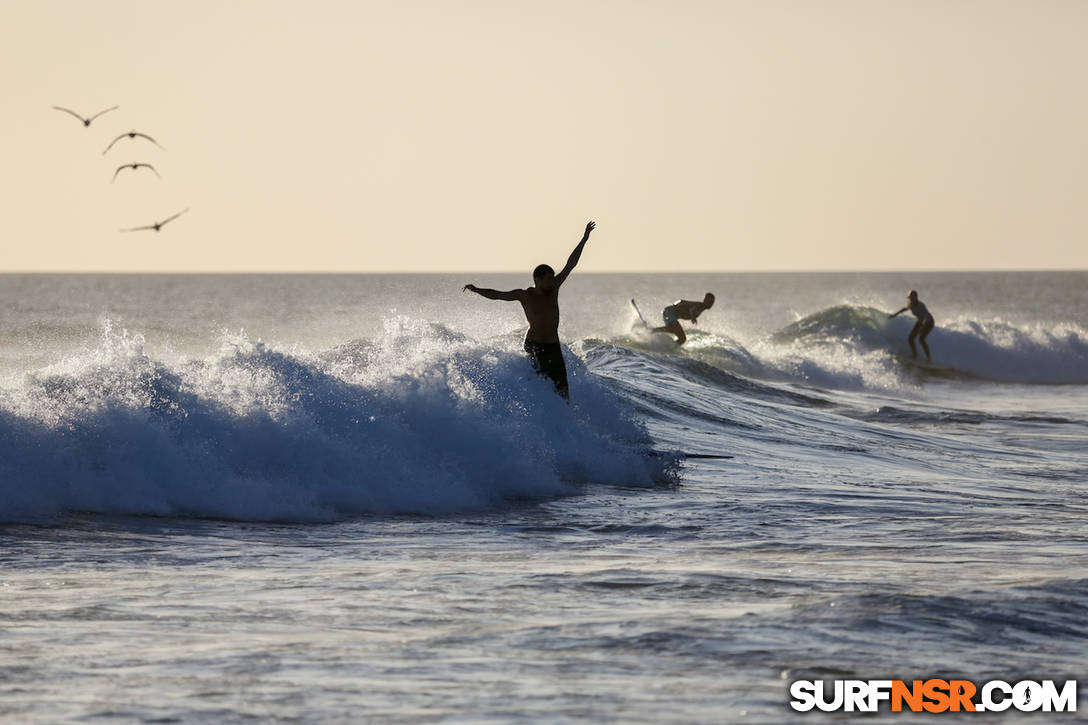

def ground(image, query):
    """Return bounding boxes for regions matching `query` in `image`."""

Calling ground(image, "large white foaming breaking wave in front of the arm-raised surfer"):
[0,319,675,521]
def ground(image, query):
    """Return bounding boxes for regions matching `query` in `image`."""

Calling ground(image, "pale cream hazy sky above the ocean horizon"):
[0,0,1088,272]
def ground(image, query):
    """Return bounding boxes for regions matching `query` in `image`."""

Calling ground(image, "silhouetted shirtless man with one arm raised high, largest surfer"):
[462,222,597,400]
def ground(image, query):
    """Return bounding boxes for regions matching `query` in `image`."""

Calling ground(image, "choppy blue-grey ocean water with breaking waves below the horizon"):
[0,272,1088,723]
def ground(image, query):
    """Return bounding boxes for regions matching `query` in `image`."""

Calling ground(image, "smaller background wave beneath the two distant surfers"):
[617,304,1088,390]
